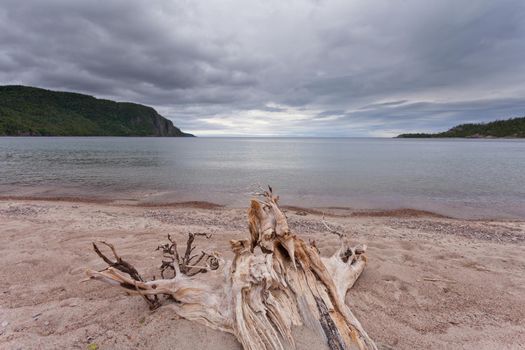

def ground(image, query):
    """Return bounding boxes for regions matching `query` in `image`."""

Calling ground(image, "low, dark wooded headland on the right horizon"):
[397,117,525,138]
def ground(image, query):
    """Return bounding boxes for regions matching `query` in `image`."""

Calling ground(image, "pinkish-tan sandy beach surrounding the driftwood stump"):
[0,198,525,349]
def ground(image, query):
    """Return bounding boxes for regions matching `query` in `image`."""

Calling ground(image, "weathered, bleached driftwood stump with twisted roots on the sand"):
[87,188,376,349]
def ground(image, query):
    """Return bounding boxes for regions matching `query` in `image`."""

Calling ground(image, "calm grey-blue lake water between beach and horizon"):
[0,137,525,218]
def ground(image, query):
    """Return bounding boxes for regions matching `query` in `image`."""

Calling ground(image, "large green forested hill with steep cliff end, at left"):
[0,86,193,136]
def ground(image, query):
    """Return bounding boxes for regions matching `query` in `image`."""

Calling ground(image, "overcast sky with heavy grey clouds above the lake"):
[0,0,525,136]
